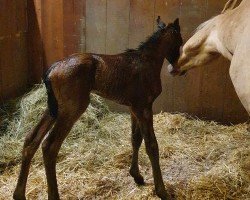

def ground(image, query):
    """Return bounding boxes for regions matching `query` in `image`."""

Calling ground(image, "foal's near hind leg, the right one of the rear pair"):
[42,97,89,200]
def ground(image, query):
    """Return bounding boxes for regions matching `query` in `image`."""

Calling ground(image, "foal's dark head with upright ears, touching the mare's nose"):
[157,17,183,64]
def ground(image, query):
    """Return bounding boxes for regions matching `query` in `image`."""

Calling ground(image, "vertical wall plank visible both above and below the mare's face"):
[173,0,206,115]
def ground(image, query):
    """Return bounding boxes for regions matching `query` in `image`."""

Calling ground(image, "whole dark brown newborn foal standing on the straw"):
[13,18,182,200]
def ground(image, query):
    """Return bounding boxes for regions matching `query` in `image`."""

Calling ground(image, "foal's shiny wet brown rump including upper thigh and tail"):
[44,54,95,117]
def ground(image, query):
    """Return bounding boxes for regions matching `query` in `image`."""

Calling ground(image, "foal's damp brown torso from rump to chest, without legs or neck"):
[48,51,162,106]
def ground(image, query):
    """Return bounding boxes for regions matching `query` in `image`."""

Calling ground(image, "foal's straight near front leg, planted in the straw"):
[132,105,169,199]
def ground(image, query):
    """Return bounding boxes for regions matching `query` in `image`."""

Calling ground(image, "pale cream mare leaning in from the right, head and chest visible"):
[169,0,250,129]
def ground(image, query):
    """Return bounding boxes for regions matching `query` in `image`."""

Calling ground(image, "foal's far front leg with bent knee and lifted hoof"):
[129,113,144,185]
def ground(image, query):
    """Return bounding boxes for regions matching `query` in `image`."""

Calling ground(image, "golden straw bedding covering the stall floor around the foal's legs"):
[0,83,250,200]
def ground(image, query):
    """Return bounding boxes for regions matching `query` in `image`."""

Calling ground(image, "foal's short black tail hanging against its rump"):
[43,66,58,118]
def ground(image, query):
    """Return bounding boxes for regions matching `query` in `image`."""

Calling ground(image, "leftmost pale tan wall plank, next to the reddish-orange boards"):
[86,0,107,53]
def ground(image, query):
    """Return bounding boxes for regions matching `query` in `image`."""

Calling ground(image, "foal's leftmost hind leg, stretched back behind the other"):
[13,110,54,200]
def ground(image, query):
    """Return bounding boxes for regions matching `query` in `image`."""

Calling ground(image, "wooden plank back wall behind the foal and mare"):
[0,0,247,123]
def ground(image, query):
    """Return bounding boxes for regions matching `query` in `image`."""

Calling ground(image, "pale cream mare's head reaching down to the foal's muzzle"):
[168,0,237,75]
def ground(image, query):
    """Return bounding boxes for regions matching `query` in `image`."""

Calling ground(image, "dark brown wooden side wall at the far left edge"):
[0,0,28,101]
